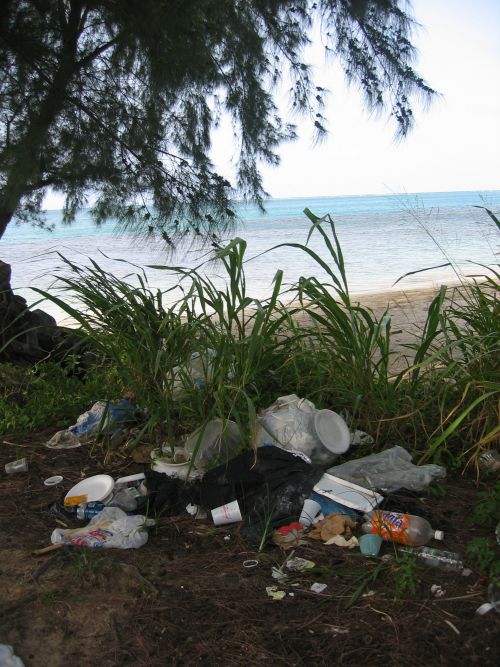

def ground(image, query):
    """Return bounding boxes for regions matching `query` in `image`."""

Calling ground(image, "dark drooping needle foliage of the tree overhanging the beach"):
[0,0,434,245]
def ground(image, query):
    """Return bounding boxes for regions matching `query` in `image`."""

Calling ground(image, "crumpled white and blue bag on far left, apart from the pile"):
[46,399,136,449]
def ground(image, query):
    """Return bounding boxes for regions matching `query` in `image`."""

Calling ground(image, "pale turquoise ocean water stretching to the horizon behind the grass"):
[0,191,500,320]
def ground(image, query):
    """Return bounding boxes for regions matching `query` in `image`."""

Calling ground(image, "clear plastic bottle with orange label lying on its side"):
[361,510,444,547]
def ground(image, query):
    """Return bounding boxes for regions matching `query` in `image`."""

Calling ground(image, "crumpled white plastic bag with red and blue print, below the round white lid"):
[50,507,154,549]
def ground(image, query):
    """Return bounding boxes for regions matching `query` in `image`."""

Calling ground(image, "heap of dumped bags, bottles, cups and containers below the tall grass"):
[31,394,459,576]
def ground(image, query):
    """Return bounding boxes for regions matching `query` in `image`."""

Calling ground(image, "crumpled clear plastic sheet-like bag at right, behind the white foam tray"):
[327,446,446,493]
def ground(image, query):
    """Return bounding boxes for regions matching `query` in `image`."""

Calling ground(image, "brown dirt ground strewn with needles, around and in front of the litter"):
[0,432,500,667]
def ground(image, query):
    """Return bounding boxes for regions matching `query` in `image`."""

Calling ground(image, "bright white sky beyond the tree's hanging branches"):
[45,0,500,208]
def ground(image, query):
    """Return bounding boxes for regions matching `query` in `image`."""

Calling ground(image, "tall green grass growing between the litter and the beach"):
[25,209,500,467]
